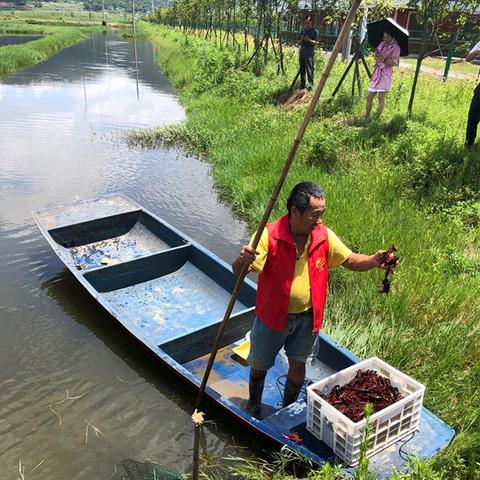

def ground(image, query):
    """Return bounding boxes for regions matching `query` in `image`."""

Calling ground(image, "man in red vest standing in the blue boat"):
[232,182,394,417]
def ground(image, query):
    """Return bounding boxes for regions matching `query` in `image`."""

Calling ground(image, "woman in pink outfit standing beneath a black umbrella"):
[365,32,400,119]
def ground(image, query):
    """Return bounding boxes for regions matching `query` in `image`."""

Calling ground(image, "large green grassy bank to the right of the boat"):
[135,23,480,480]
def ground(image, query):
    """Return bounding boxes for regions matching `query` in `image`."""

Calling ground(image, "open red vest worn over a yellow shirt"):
[255,215,328,332]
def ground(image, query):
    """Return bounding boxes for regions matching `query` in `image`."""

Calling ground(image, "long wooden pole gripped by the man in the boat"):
[195,0,362,409]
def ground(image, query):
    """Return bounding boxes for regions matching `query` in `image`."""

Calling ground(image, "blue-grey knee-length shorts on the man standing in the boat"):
[247,309,318,370]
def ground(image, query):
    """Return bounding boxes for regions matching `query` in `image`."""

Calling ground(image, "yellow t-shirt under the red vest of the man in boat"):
[250,227,352,313]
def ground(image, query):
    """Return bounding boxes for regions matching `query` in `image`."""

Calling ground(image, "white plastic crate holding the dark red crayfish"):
[307,357,425,466]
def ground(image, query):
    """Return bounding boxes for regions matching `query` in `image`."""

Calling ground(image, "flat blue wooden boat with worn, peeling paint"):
[33,195,454,478]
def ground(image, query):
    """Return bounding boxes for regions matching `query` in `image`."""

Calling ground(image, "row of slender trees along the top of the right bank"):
[150,0,478,114]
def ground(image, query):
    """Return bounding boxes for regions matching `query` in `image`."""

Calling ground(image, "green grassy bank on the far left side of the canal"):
[0,18,103,78]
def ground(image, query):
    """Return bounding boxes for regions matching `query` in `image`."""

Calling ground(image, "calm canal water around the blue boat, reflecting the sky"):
[0,33,250,480]
